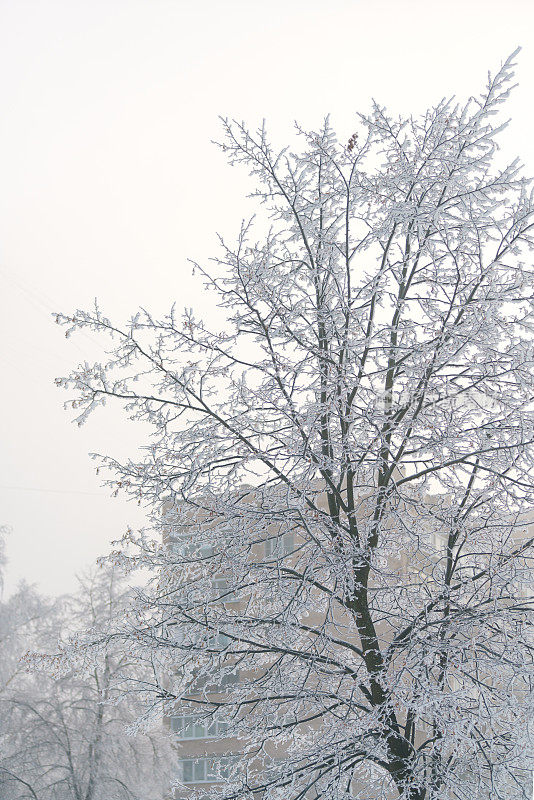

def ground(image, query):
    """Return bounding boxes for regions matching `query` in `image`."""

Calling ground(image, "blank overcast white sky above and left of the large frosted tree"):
[0,0,534,593]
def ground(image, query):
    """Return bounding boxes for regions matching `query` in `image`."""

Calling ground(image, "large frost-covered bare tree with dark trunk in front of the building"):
[58,54,534,800]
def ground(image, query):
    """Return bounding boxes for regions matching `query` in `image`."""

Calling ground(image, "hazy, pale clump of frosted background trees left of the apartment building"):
[0,569,172,800]
